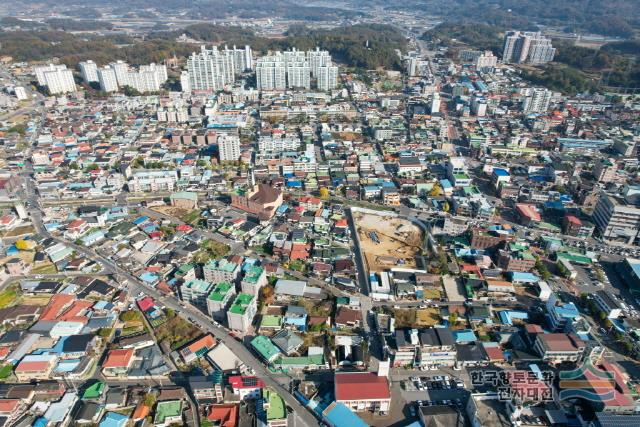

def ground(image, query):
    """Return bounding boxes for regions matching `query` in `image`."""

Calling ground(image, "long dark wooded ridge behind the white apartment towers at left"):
[0,24,407,69]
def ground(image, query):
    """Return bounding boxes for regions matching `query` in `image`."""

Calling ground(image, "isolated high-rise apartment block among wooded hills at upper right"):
[502,31,556,64]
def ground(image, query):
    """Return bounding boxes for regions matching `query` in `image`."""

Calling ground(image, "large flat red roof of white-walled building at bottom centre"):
[334,372,391,402]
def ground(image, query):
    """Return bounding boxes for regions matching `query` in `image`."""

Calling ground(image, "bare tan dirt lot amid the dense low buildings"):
[353,212,423,272]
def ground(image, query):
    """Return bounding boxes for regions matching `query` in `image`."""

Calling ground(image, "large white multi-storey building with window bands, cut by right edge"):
[593,193,640,244]
